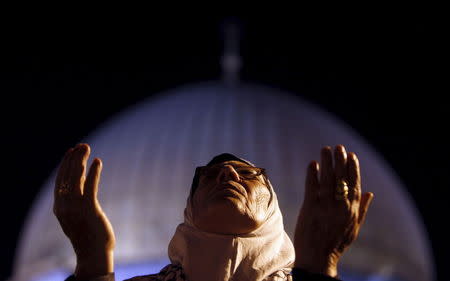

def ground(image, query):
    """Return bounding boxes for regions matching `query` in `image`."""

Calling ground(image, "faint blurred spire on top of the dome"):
[220,20,241,85]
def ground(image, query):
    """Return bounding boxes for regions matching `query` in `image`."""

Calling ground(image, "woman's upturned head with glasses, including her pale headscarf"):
[168,153,295,281]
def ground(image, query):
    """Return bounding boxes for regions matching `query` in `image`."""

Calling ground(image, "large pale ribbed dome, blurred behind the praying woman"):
[13,82,434,281]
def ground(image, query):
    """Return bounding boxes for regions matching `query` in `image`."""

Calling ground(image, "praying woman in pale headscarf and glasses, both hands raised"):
[54,144,373,281]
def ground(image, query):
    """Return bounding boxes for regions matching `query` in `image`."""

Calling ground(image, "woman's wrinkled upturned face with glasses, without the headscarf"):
[193,161,271,234]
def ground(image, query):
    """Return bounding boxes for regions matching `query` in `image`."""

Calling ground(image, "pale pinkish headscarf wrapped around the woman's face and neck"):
[168,175,295,281]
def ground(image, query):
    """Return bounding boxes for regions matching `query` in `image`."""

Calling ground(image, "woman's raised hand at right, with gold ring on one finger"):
[294,145,373,277]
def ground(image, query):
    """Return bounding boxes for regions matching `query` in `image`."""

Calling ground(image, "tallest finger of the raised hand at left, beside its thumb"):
[69,144,90,195]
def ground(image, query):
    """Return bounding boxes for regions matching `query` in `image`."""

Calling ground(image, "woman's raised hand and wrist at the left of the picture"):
[53,144,115,279]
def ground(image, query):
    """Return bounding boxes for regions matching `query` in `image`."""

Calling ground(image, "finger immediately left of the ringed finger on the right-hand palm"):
[320,146,335,200]
